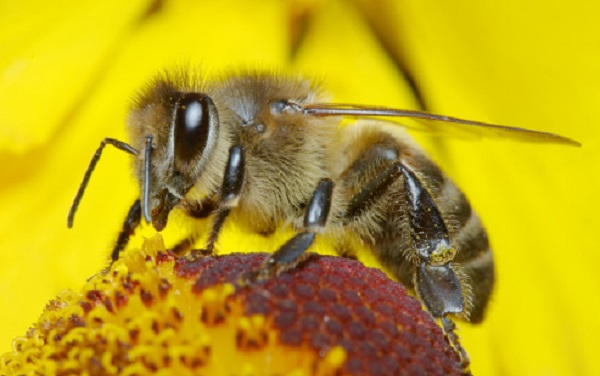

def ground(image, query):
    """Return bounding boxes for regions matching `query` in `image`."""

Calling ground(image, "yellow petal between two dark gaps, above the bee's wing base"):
[293,0,415,107]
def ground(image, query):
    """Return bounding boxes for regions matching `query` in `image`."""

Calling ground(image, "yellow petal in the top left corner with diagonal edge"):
[0,0,147,154]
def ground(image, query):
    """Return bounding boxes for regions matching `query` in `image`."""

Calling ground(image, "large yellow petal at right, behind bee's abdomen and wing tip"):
[354,0,600,375]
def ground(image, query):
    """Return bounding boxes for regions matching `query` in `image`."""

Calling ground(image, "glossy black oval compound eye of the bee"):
[174,93,216,162]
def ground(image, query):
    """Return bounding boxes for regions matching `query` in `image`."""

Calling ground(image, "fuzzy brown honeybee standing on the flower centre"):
[68,69,579,364]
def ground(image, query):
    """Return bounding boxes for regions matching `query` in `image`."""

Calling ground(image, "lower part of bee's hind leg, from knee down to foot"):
[400,164,470,373]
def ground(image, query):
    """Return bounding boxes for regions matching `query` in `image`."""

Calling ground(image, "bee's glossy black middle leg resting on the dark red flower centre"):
[242,179,334,283]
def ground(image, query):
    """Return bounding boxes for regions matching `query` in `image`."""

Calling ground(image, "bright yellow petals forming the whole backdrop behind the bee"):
[0,0,600,375]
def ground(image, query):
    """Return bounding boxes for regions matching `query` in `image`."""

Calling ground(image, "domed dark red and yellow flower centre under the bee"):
[0,235,462,376]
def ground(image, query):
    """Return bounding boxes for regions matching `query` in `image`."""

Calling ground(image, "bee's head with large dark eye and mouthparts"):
[131,92,219,231]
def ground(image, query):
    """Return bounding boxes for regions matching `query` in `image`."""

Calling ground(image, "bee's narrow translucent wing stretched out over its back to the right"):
[301,103,581,146]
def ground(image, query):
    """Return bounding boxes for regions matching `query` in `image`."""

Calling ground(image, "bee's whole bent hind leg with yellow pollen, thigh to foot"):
[345,160,470,374]
